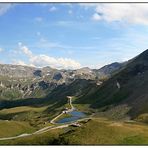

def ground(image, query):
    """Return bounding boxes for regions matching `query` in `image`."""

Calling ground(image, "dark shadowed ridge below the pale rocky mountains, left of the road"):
[0,79,94,111]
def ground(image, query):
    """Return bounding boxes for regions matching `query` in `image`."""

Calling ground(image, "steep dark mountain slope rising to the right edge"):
[75,50,148,118]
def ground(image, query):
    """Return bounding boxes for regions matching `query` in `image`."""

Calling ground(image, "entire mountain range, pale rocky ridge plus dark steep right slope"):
[0,50,148,121]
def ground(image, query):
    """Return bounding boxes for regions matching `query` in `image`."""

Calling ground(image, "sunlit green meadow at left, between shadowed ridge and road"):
[0,106,48,128]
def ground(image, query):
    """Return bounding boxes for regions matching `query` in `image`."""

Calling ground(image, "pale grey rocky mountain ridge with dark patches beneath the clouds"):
[0,64,121,99]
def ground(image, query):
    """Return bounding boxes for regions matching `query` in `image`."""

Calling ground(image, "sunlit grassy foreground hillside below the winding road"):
[0,118,148,145]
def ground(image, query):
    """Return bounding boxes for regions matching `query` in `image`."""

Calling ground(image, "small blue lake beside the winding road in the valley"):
[56,110,86,123]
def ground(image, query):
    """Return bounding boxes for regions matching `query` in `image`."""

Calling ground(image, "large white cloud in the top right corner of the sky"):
[80,3,148,25]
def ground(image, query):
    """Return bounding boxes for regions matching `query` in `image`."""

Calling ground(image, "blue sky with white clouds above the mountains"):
[0,3,148,69]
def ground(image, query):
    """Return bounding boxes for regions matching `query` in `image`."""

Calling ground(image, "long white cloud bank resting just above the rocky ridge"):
[15,43,81,69]
